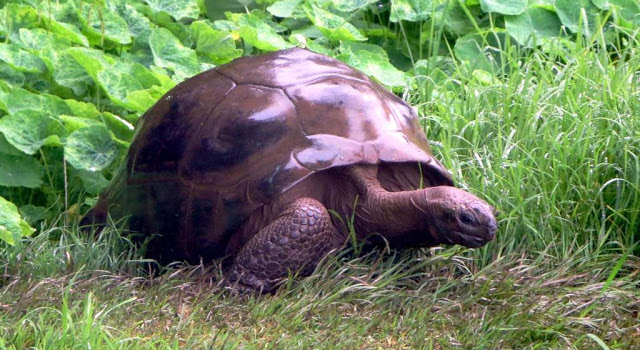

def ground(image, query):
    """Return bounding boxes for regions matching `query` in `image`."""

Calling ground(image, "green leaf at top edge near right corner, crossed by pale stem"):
[554,0,600,36]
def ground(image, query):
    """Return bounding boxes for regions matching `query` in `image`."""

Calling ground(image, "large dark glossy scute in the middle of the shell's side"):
[178,85,308,193]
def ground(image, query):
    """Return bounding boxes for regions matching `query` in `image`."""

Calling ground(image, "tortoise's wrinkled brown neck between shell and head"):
[348,166,443,247]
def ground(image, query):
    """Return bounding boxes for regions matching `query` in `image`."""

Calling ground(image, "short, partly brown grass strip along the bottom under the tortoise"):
[0,234,640,349]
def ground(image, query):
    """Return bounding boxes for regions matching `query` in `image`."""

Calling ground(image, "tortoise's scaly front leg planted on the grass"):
[228,198,344,292]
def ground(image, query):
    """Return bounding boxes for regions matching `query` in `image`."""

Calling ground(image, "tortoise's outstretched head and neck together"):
[348,165,498,248]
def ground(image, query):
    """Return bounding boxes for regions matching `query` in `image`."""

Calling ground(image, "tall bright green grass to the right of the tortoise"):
[414,30,640,263]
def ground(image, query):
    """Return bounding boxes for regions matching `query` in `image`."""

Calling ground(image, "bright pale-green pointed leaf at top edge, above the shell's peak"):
[303,3,367,41]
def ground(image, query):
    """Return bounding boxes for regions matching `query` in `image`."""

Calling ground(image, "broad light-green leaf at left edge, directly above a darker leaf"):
[0,109,66,154]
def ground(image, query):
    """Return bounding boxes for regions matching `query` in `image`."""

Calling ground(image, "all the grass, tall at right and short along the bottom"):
[0,25,640,349]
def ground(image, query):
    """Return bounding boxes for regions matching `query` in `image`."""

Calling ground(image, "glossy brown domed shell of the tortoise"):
[97,48,453,258]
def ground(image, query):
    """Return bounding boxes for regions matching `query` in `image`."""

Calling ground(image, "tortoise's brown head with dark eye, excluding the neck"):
[422,186,498,248]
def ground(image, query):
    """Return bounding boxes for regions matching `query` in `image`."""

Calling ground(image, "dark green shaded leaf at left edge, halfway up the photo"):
[0,153,43,188]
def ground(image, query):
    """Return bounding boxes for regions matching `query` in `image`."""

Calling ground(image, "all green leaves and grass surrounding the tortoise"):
[0,0,640,349]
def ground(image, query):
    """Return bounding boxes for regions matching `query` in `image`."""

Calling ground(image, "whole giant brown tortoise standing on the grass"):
[82,48,497,291]
